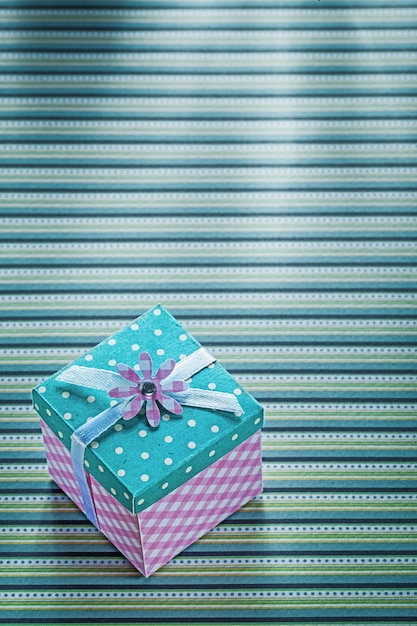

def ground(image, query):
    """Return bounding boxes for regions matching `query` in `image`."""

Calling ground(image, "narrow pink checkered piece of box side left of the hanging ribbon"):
[40,419,88,513]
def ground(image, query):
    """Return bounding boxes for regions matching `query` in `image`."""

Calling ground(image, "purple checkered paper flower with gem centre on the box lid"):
[109,352,188,426]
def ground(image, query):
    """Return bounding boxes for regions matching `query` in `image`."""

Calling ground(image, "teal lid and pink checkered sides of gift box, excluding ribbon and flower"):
[33,305,263,576]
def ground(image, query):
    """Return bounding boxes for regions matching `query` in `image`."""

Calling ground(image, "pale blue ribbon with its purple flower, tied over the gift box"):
[56,348,243,528]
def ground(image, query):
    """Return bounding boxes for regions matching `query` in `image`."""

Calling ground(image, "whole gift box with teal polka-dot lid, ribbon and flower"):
[33,305,263,576]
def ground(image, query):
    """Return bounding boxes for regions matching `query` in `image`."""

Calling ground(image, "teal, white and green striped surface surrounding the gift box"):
[0,0,417,626]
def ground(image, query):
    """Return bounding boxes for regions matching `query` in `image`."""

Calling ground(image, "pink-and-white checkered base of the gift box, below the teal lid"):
[41,420,262,576]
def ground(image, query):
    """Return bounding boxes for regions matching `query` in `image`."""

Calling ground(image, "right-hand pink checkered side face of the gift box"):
[138,431,262,576]
